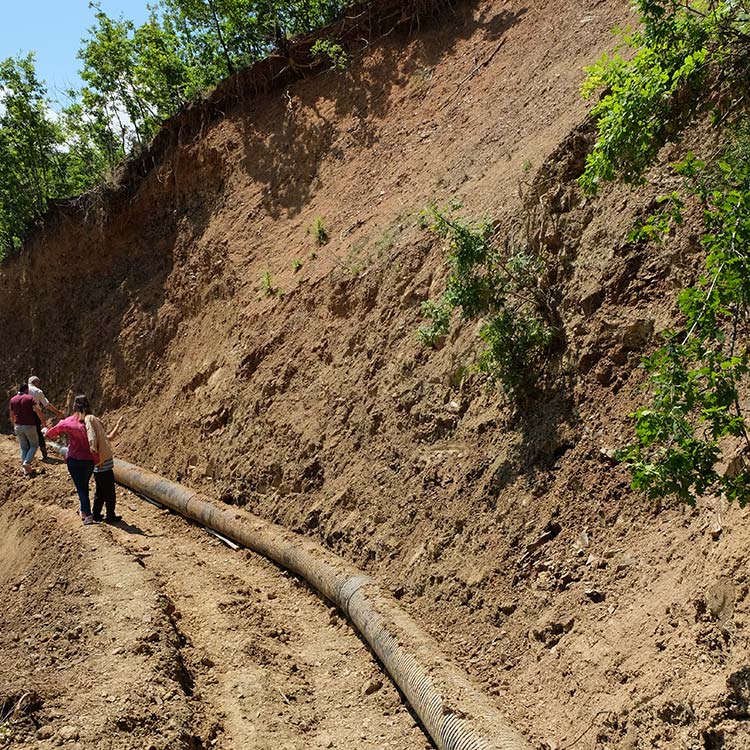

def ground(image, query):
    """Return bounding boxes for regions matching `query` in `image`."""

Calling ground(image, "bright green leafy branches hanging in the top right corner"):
[580,0,750,193]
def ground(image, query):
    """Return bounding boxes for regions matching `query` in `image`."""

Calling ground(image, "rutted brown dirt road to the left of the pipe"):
[0,437,432,750]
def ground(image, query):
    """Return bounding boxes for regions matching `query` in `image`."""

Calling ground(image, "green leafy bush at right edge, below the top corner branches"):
[621,137,750,505]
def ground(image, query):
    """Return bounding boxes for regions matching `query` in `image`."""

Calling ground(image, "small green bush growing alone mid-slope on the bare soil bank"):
[418,207,553,399]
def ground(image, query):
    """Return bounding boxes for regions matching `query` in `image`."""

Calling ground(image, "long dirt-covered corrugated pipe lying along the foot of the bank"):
[50,444,529,750]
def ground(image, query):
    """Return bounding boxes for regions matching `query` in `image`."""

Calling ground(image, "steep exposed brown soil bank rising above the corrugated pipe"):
[0,0,750,750]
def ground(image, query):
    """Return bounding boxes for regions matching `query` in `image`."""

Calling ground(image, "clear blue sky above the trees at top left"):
[0,0,153,96]
